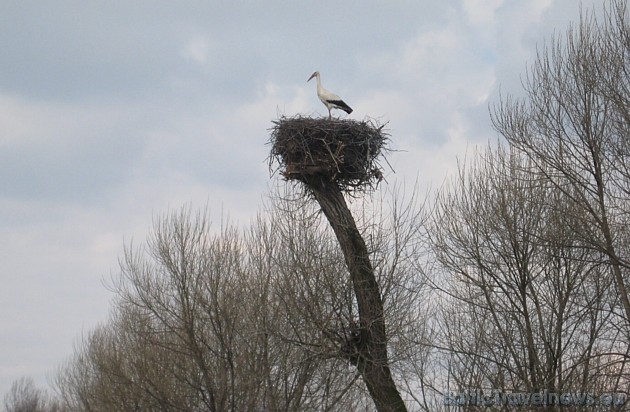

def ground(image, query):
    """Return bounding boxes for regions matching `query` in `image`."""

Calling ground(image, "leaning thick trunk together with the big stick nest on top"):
[270,117,406,411]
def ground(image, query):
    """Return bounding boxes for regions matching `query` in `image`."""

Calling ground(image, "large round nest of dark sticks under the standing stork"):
[269,116,389,192]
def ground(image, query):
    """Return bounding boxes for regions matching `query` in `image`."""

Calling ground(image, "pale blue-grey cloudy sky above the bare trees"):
[0,0,601,397]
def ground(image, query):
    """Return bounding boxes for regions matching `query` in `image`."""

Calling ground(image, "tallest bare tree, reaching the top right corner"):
[493,0,630,334]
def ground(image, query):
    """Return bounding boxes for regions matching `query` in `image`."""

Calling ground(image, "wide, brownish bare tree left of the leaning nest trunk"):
[58,210,308,411]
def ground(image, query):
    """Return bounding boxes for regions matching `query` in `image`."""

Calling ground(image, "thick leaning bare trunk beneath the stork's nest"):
[305,179,407,411]
